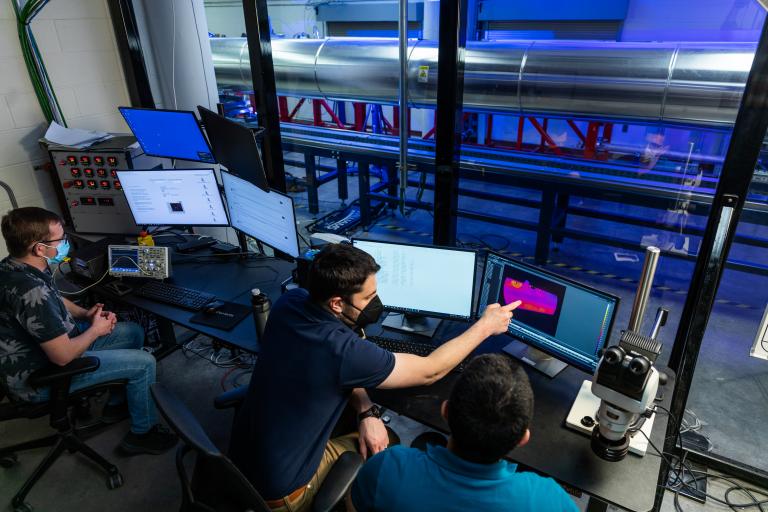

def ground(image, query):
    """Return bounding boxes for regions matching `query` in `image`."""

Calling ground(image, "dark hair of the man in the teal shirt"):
[447,354,533,464]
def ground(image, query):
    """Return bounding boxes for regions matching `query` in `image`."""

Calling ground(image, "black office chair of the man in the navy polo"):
[152,384,363,512]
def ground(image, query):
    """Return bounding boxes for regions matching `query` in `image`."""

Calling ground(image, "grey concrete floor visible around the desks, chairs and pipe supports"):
[0,158,768,512]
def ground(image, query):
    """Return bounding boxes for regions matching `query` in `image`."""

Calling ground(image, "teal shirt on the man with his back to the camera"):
[352,446,578,512]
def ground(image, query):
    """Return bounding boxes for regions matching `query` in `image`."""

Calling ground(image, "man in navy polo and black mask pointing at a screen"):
[229,244,519,512]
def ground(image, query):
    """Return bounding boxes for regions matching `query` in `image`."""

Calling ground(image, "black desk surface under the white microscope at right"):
[369,321,674,511]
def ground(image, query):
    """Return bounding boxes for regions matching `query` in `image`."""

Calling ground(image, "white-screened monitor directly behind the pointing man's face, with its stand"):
[352,239,477,336]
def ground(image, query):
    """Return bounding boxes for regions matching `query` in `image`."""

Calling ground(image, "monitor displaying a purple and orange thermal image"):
[477,252,619,376]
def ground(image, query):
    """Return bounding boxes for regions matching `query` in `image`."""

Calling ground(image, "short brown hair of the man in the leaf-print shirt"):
[2,206,63,258]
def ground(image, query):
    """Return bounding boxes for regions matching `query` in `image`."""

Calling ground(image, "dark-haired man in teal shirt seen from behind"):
[347,354,578,512]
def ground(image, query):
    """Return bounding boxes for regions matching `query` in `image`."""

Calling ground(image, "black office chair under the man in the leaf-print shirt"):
[0,357,127,512]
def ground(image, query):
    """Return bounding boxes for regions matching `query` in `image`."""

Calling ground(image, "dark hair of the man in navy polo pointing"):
[308,244,381,302]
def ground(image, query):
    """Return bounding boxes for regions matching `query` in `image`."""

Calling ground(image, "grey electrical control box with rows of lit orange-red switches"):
[48,136,163,234]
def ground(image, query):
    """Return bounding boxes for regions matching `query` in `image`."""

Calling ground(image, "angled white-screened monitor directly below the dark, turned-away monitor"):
[221,171,299,258]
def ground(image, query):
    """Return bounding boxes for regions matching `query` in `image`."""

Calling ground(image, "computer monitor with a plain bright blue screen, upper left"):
[119,107,216,164]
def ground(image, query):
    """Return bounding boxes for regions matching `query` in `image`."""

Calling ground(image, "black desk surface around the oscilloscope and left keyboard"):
[63,251,295,353]
